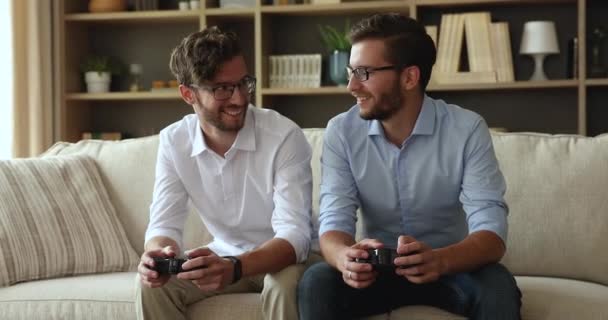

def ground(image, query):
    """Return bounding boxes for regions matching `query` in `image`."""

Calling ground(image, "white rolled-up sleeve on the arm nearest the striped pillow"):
[145,131,188,248]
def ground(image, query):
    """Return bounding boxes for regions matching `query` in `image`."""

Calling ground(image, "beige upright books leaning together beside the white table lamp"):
[426,12,514,84]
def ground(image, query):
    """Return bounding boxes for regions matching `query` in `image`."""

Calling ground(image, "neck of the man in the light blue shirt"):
[382,95,424,148]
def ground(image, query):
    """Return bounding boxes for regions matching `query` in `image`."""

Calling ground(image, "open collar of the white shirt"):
[190,104,255,157]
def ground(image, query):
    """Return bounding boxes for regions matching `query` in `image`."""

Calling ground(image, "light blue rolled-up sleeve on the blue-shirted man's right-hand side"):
[460,119,509,245]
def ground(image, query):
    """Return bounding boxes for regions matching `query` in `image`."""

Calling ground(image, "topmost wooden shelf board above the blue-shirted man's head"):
[261,1,410,16]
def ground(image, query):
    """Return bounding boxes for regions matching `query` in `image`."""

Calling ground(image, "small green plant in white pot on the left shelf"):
[80,55,122,93]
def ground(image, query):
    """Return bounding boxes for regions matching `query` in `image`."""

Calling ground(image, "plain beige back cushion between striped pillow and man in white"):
[44,135,212,255]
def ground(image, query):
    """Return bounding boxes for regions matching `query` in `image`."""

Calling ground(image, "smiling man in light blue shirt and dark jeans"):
[298,14,521,320]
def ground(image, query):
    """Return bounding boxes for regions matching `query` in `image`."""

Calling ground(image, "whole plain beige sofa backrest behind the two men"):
[45,129,608,284]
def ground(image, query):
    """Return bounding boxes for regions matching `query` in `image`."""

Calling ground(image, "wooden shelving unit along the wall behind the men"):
[55,0,608,141]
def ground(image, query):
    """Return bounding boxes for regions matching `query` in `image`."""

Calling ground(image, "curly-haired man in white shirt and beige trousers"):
[137,27,312,319]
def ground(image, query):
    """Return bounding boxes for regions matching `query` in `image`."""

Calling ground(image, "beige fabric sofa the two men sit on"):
[0,129,608,320]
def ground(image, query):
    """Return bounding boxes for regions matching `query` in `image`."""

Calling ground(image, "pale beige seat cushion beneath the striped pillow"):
[0,272,136,320]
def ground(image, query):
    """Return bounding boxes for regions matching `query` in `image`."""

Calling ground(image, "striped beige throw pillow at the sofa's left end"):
[0,156,138,287]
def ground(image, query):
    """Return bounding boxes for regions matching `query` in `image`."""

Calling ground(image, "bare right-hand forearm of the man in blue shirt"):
[436,231,506,274]
